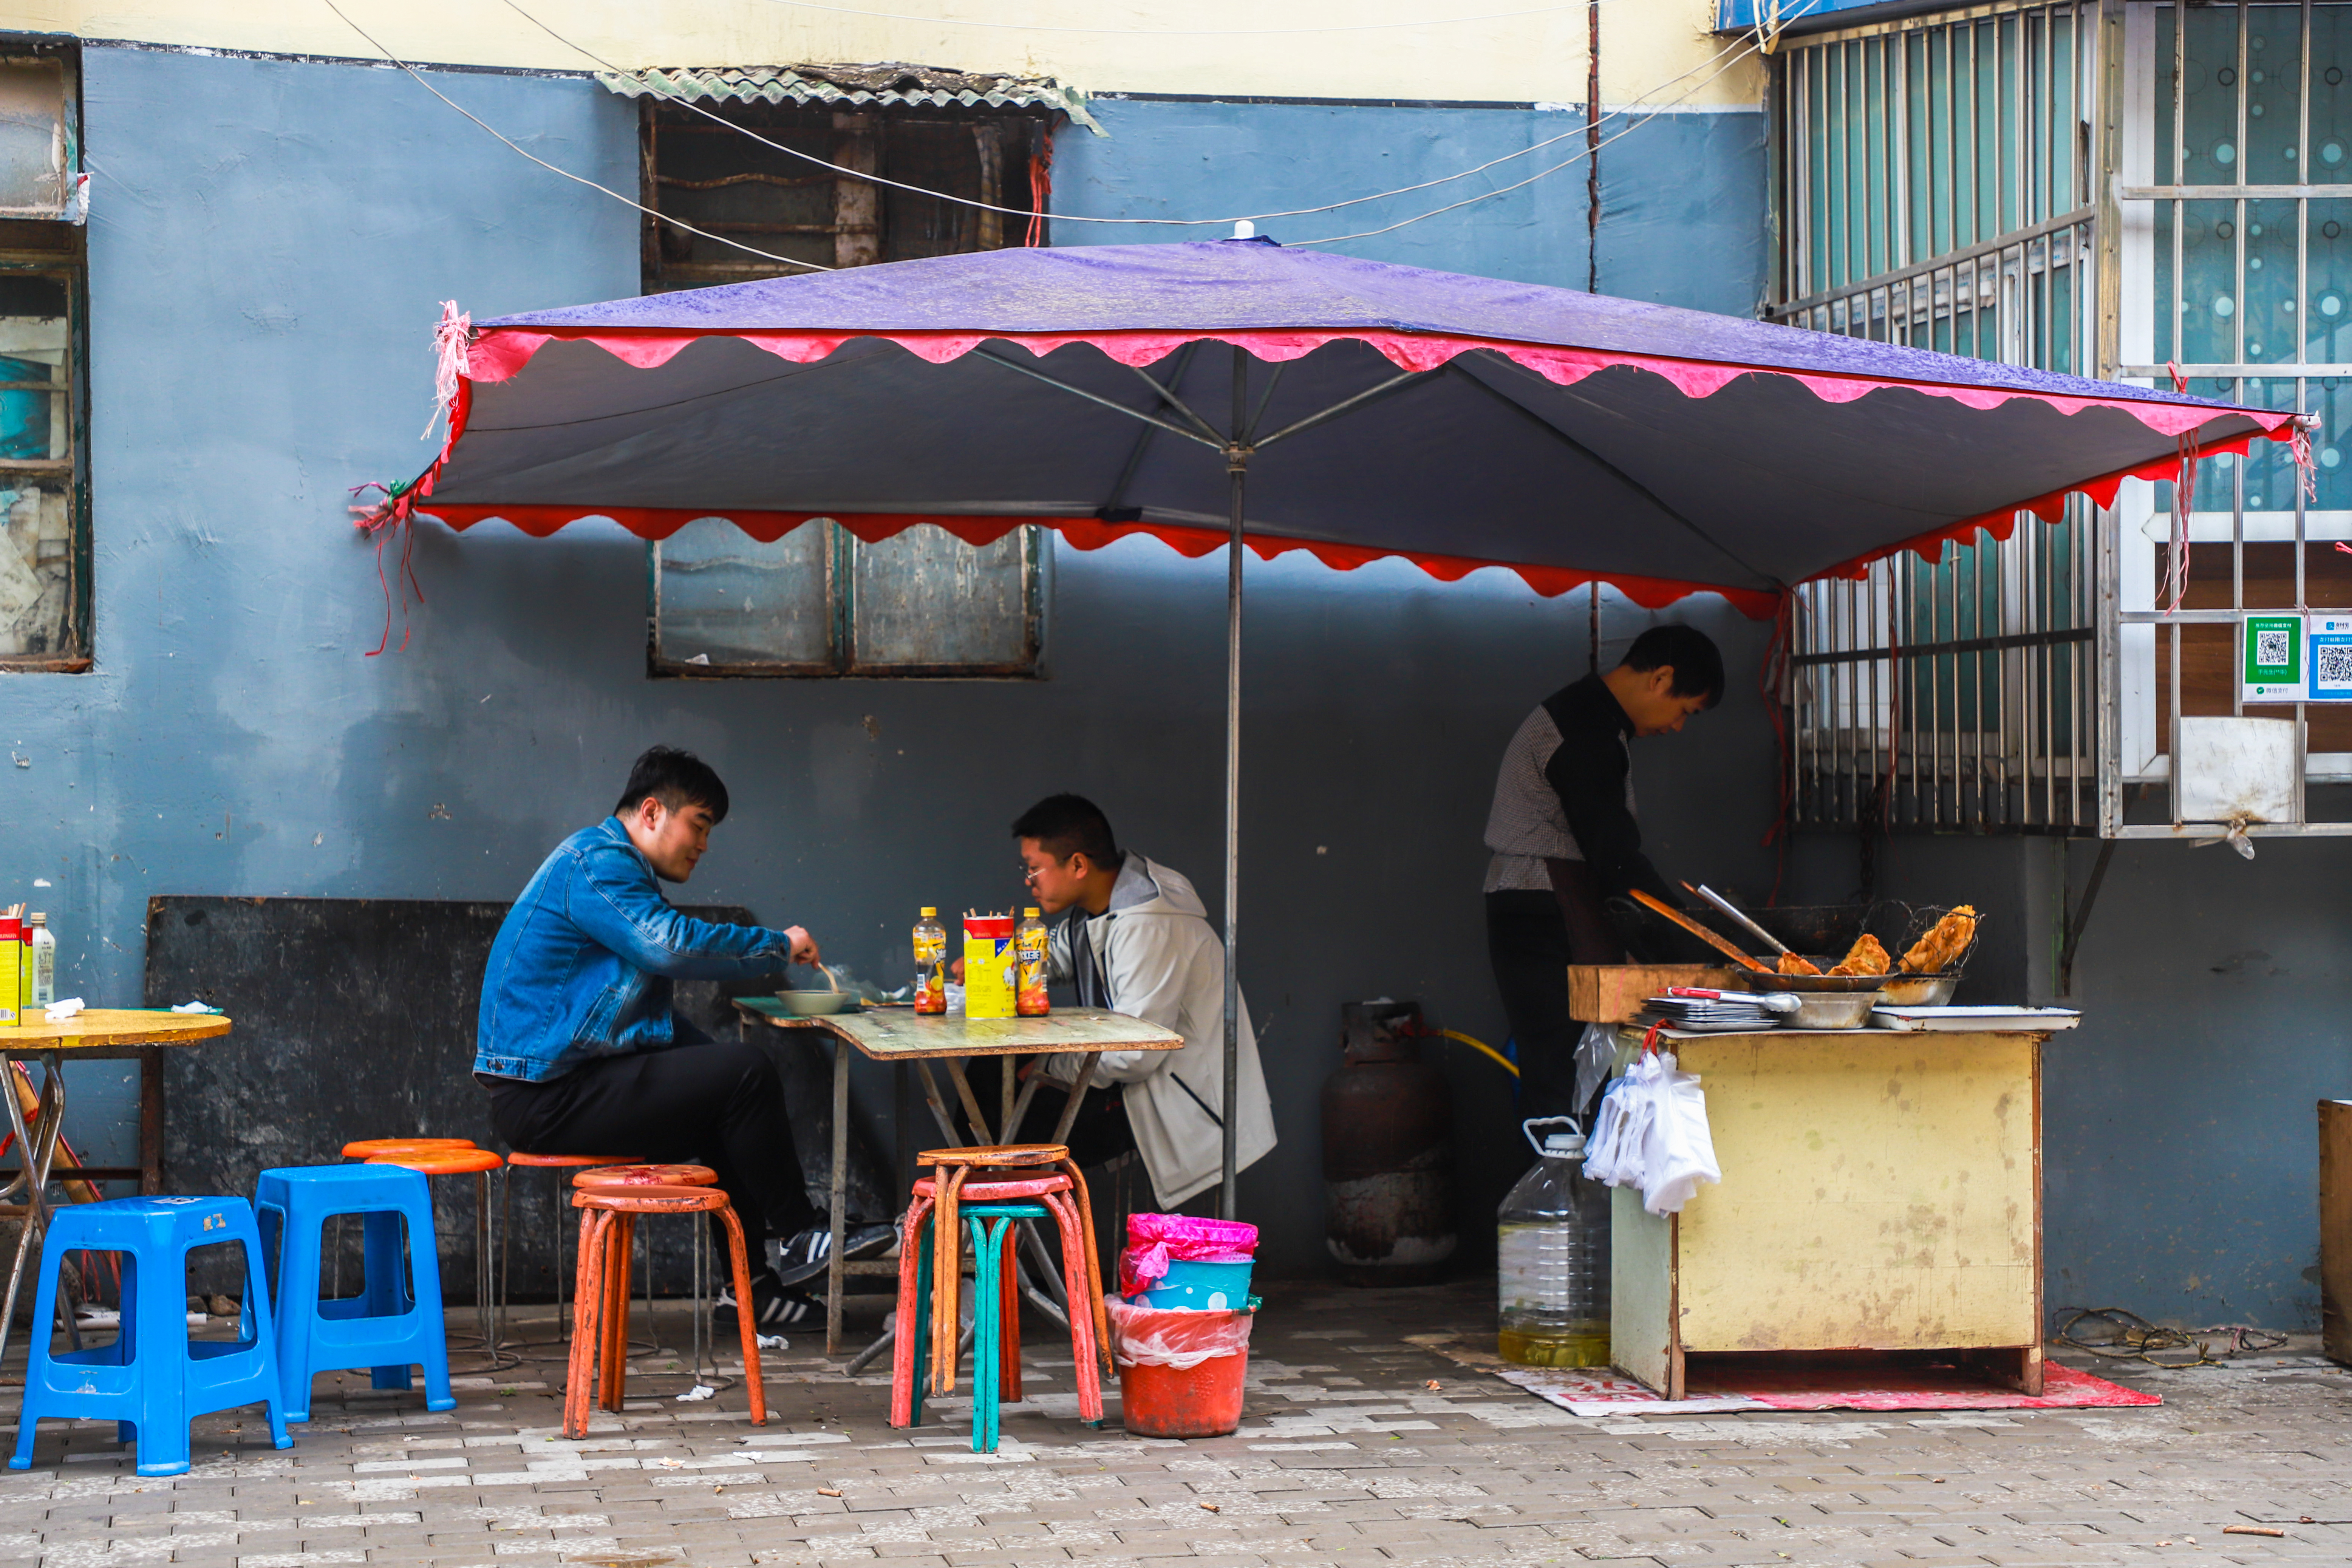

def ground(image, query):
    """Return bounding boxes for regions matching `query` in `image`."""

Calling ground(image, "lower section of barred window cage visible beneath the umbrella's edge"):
[1788,503,2098,835]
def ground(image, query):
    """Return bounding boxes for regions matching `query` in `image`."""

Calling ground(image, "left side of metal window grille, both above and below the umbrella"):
[1766,2,2100,832]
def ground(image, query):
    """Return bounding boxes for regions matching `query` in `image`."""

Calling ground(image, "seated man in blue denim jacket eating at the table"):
[473,745,889,1331]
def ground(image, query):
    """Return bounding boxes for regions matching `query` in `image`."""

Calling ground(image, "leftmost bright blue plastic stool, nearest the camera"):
[9,1199,294,1476]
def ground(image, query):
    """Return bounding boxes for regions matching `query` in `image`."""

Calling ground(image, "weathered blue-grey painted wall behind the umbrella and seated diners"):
[0,49,1769,1272]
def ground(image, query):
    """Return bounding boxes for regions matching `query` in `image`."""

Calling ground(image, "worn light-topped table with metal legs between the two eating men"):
[736,997,1183,1359]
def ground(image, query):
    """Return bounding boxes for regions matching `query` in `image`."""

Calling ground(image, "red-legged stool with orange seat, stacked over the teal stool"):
[889,1171,1103,1427]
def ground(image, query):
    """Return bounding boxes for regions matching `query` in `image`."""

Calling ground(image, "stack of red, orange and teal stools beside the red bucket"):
[889,1171,1103,1453]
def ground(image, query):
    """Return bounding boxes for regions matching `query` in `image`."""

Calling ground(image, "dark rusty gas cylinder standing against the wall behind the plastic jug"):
[1322,999,1454,1286]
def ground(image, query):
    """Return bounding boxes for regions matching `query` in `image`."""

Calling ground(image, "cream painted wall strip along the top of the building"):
[0,0,1762,108]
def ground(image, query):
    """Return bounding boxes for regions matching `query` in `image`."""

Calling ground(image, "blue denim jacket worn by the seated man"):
[473,816,793,1084]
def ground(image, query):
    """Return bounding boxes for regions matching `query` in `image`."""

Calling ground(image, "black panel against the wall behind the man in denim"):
[146,898,891,1302]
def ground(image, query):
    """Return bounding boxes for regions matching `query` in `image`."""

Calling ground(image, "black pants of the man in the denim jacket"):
[489,1041,826,1267]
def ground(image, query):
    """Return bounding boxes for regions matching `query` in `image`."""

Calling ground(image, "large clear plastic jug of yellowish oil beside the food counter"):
[1496,1116,1609,1366]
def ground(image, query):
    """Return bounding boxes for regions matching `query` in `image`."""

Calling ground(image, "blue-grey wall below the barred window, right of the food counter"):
[1790,835,2352,1331]
